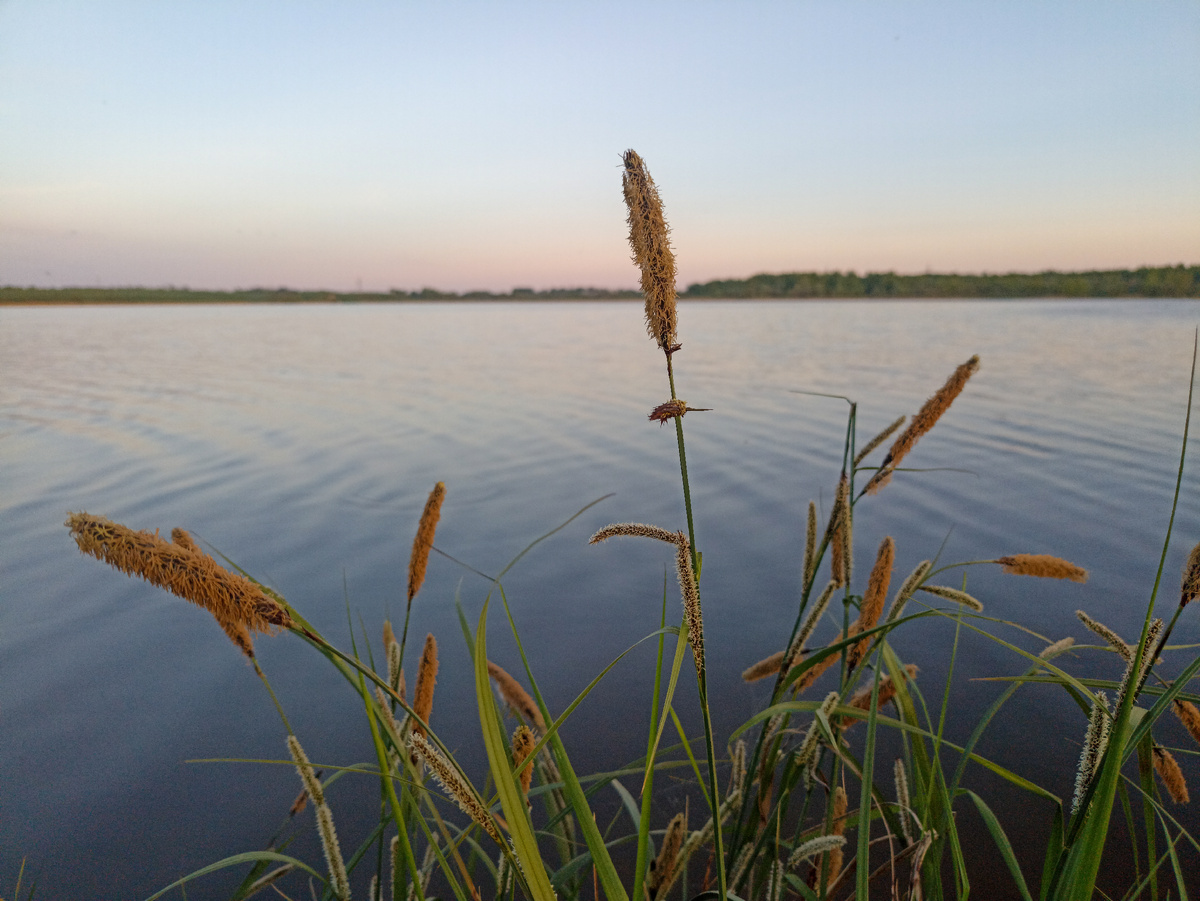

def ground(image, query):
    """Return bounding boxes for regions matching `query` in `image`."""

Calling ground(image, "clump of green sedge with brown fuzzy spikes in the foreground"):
[67,151,1200,901]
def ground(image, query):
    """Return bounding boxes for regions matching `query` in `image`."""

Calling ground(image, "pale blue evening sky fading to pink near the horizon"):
[0,0,1200,292]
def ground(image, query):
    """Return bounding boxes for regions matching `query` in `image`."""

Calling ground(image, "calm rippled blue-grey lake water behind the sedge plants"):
[0,301,1200,899]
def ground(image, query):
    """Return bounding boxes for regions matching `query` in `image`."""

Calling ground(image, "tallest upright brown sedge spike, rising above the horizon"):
[622,150,677,354]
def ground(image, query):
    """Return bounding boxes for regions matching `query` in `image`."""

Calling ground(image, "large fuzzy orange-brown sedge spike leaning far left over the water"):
[65,512,293,659]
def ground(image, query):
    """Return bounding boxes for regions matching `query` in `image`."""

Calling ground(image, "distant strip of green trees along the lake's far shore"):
[0,264,1200,306]
